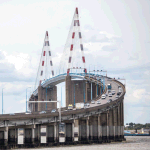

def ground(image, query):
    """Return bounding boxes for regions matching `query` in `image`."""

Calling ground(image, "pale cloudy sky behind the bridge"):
[0,0,150,123]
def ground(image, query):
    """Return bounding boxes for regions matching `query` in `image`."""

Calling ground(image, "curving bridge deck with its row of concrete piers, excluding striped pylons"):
[0,74,126,149]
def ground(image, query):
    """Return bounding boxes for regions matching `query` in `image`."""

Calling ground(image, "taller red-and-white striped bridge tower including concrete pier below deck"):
[65,8,92,106]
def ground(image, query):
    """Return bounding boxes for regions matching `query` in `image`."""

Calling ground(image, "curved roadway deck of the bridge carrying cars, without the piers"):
[0,74,126,122]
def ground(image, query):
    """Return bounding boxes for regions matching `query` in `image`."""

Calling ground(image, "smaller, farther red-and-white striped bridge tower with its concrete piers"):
[29,31,57,111]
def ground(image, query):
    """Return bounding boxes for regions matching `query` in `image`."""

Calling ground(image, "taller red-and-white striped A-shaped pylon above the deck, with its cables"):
[60,8,87,75]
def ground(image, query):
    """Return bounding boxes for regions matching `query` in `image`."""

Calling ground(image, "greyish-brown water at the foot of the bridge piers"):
[14,136,150,150]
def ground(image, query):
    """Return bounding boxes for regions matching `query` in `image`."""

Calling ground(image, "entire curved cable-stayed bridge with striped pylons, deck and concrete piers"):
[0,8,126,149]
